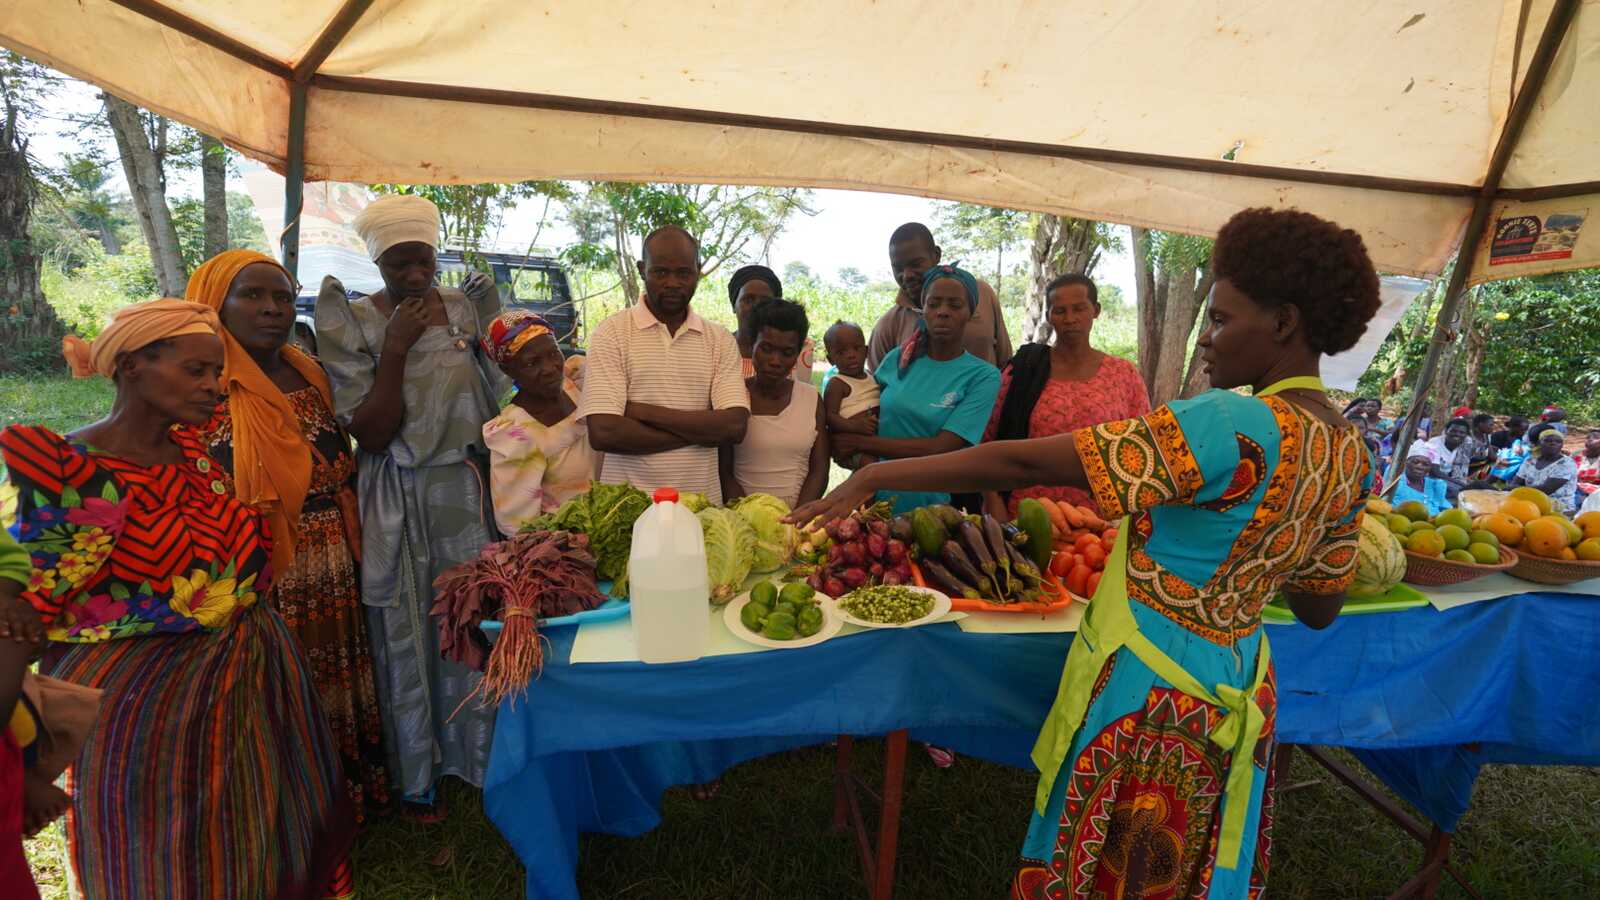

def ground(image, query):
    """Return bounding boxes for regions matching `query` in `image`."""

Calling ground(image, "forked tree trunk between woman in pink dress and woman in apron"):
[1131,226,1214,404]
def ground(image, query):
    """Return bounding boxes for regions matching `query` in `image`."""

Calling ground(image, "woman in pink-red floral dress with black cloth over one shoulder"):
[984,274,1150,519]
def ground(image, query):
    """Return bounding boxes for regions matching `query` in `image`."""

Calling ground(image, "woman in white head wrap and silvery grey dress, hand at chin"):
[317,195,509,817]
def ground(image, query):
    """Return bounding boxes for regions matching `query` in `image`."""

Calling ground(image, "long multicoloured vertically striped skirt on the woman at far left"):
[51,604,355,900]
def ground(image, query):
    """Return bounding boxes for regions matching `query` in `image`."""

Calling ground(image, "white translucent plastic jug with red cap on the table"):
[627,487,710,663]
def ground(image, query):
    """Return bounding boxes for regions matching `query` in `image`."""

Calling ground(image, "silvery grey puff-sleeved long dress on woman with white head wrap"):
[317,277,510,802]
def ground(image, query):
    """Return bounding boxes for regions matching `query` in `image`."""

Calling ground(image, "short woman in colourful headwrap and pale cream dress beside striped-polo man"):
[483,309,597,535]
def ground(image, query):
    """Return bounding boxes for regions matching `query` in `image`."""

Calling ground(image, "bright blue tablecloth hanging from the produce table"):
[483,594,1600,898]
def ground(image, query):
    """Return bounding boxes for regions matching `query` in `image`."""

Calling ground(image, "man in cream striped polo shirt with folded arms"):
[578,226,750,503]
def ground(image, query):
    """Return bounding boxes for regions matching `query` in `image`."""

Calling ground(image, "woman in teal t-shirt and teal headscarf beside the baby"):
[834,266,1000,512]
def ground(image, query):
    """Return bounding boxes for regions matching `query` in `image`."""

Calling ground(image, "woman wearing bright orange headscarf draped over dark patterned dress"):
[187,250,389,839]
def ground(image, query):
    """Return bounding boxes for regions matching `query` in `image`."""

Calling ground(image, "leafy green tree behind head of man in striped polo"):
[563,181,816,304]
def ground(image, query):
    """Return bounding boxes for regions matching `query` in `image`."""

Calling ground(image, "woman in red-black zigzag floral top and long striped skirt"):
[0,299,355,900]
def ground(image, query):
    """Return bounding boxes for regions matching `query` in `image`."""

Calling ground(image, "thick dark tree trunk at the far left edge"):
[0,109,66,372]
